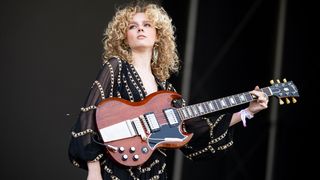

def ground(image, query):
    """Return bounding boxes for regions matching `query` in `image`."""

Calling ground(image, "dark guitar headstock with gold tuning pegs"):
[269,79,299,105]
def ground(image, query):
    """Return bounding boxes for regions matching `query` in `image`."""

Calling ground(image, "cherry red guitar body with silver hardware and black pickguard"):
[96,91,192,166]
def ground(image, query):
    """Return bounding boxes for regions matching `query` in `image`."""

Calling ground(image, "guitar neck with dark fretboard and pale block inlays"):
[176,87,272,120]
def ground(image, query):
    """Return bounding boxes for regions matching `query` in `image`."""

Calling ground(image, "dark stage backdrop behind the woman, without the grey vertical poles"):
[0,0,319,180]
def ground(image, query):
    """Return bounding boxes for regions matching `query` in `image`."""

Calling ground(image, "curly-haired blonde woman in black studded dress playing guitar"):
[69,3,268,180]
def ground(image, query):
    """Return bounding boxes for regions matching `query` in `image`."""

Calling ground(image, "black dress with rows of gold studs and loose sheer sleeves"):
[68,57,233,180]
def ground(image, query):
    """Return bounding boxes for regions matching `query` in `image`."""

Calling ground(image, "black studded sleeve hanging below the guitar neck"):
[167,83,233,160]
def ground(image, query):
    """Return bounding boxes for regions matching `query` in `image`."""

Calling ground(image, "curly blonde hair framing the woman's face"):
[103,2,179,81]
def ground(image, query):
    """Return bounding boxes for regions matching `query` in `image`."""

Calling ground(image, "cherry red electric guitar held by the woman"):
[96,80,299,166]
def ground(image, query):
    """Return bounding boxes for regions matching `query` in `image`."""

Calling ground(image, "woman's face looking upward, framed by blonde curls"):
[127,13,157,50]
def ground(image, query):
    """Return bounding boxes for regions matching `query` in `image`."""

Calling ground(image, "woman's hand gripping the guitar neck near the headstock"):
[248,86,269,114]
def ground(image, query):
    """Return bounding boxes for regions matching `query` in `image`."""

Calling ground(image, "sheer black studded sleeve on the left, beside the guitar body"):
[68,58,121,169]
